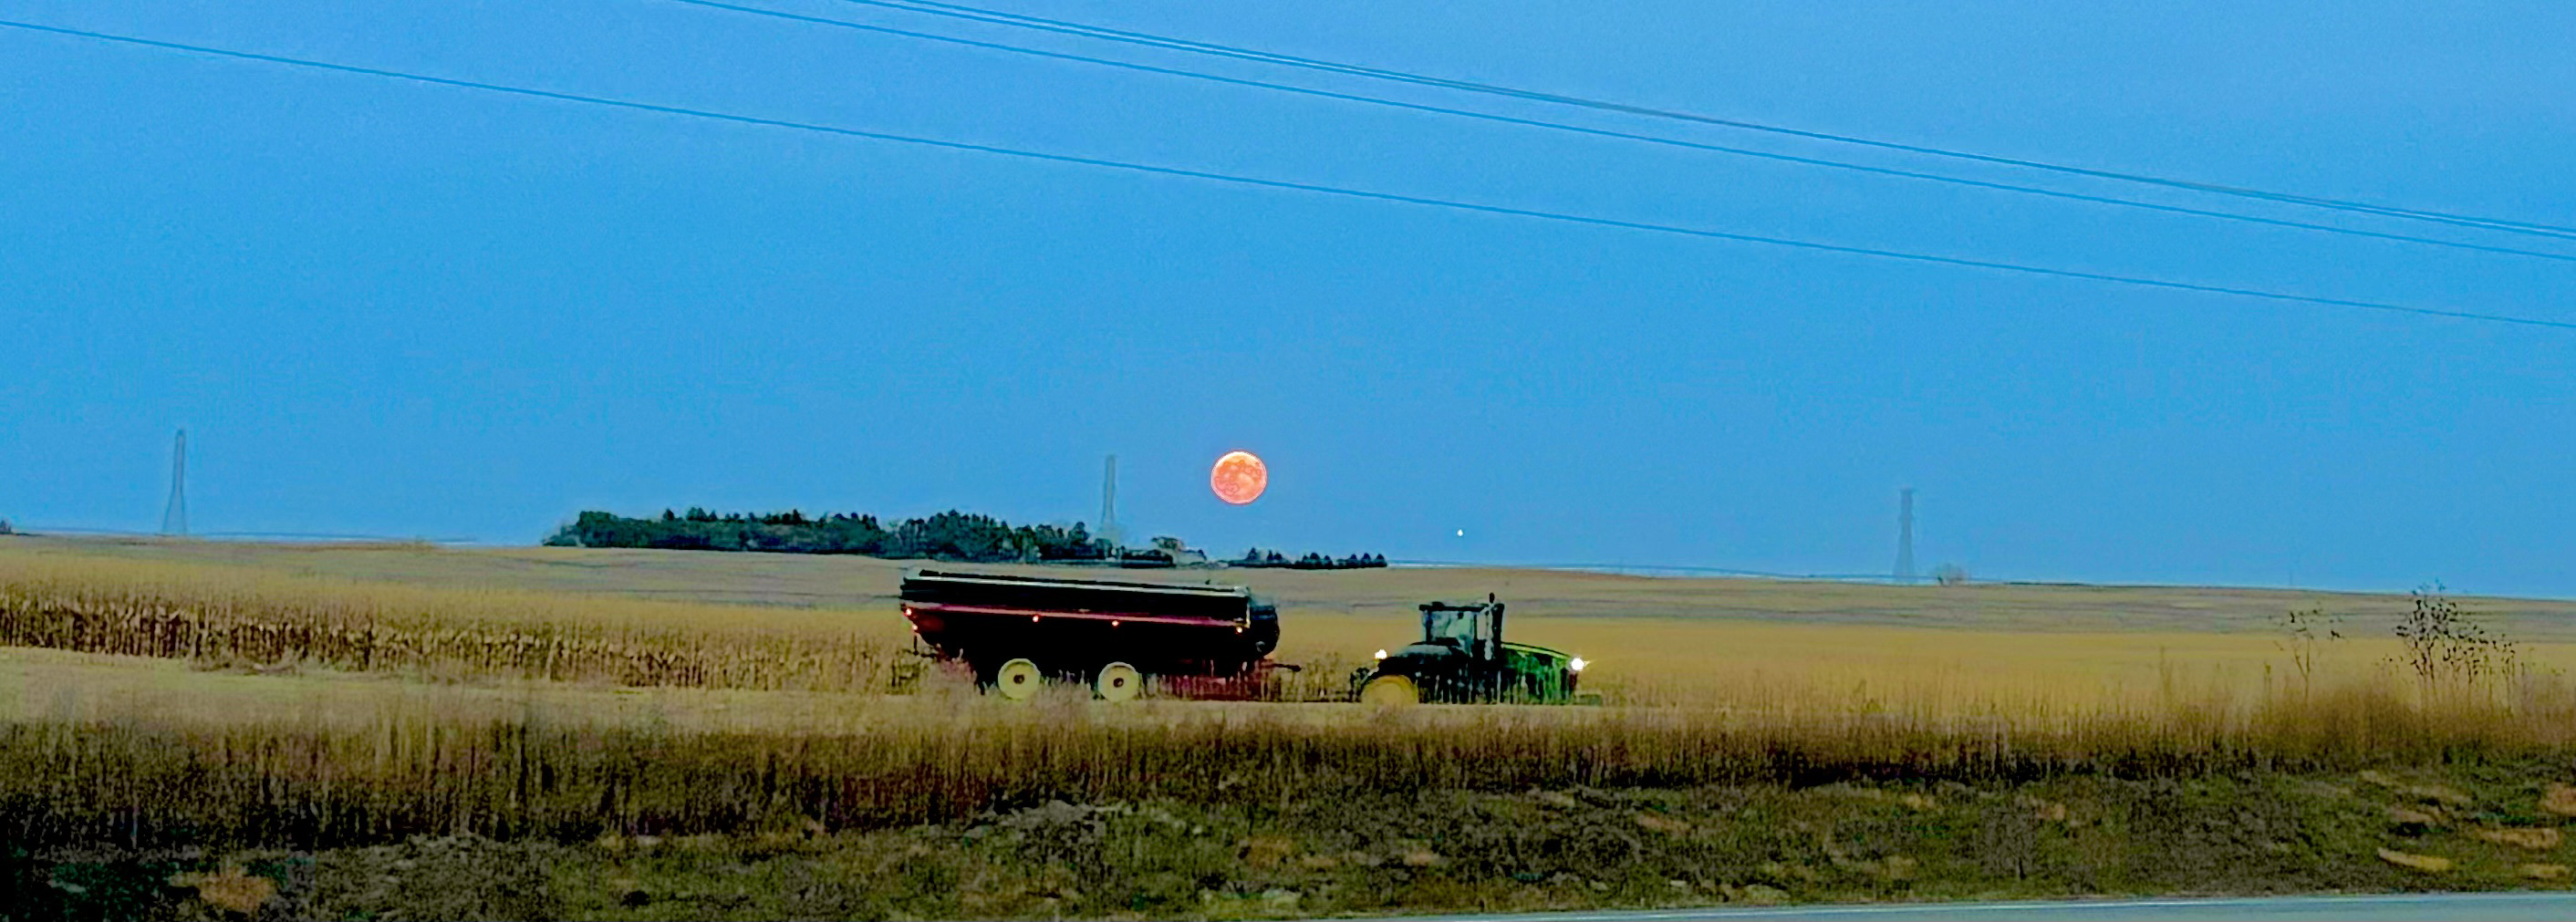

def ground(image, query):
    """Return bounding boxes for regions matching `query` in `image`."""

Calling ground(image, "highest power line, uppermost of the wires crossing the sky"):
[842,0,2576,240]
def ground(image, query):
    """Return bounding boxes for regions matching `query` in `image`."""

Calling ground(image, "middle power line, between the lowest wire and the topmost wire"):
[649,0,2576,263]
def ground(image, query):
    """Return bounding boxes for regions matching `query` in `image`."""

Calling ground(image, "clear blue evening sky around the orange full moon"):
[0,0,2576,595]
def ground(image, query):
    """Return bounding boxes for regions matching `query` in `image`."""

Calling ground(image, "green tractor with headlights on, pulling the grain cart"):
[1350,595,1597,706]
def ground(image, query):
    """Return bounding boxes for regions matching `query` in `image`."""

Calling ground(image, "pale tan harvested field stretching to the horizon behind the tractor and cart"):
[20,535,2576,641]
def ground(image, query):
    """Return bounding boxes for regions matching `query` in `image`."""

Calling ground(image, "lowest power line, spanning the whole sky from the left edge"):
[0,21,2576,329]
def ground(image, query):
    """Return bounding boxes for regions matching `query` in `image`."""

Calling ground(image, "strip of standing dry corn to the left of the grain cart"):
[0,551,901,690]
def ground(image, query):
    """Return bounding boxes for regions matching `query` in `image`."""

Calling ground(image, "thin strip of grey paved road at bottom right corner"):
[1419,894,2576,922]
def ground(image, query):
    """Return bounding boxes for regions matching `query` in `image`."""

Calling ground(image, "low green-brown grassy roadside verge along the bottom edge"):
[15,762,2576,919]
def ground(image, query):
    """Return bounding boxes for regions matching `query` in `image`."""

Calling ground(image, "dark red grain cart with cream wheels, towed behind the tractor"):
[899,569,1293,700]
